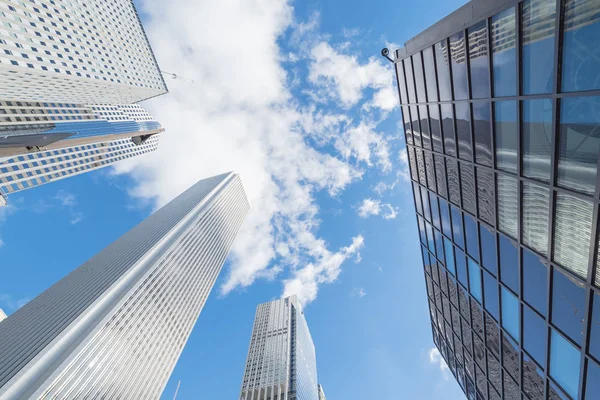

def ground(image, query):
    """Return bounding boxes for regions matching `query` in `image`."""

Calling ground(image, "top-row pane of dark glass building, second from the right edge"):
[521,0,556,94]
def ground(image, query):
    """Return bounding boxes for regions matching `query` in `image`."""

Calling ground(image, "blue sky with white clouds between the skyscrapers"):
[0,0,464,400]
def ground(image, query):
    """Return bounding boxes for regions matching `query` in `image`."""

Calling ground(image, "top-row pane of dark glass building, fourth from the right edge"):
[468,20,490,99]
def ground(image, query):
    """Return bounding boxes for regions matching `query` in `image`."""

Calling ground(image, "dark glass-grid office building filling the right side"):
[393,0,600,400]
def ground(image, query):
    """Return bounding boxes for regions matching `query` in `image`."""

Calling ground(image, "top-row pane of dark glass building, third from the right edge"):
[492,7,517,96]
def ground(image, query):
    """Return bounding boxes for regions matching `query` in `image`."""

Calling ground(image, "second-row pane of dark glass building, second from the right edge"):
[522,99,553,182]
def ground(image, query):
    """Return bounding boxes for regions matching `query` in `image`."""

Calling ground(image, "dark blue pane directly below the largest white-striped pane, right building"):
[552,269,585,346]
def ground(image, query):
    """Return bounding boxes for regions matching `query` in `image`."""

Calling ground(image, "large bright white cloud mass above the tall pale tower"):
[110,0,368,303]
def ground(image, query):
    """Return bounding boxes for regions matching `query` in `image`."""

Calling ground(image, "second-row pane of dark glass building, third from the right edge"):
[494,101,518,174]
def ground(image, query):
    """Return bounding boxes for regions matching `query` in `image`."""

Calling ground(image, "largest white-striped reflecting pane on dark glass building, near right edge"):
[554,193,594,279]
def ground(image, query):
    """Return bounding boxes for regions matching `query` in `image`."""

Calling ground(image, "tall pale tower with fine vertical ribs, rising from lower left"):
[0,173,249,400]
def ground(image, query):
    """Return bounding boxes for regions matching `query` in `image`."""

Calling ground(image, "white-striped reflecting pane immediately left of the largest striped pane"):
[521,182,550,255]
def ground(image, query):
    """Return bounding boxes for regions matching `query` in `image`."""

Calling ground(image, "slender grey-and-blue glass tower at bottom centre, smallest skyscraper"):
[240,296,319,400]
